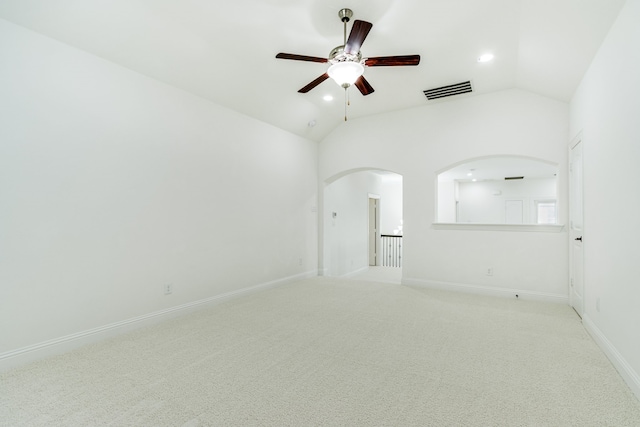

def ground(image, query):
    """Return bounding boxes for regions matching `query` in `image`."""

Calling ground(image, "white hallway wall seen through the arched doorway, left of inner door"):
[323,172,382,276]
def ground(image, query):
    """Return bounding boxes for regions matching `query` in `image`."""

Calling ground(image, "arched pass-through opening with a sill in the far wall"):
[436,156,558,224]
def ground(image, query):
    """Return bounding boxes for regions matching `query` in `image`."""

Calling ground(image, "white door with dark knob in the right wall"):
[569,140,584,317]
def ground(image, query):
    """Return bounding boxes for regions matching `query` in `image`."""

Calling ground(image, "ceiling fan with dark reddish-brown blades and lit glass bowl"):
[276,8,420,95]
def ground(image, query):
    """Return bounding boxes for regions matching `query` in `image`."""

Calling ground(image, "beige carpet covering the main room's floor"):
[0,278,640,426]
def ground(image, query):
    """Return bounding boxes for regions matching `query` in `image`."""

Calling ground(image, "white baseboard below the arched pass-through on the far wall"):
[401,277,569,304]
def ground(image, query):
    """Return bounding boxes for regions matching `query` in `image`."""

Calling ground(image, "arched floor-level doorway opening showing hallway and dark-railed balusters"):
[322,169,403,283]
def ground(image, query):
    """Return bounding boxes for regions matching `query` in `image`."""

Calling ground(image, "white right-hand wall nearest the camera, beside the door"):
[571,0,640,397]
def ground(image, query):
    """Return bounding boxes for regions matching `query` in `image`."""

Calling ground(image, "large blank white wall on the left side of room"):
[0,20,317,359]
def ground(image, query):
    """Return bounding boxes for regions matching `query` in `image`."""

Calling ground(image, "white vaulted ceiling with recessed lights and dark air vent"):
[0,0,624,141]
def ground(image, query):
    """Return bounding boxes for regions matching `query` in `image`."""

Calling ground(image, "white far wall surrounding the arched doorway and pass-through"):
[319,90,568,300]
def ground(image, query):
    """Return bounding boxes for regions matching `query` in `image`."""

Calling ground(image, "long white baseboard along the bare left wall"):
[0,271,317,372]
